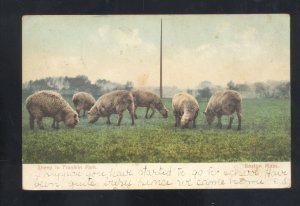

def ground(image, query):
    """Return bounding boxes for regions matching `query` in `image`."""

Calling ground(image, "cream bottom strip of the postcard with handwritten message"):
[23,162,291,190]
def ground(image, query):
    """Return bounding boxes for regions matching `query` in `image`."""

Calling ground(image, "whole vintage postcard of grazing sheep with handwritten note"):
[22,14,291,190]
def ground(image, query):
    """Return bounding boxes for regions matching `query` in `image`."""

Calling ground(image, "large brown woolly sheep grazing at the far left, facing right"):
[26,90,79,129]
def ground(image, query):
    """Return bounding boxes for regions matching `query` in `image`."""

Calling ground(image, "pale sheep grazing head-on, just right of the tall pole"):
[172,92,199,128]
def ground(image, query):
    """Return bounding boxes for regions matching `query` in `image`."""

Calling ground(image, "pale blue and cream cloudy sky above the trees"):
[22,14,290,88]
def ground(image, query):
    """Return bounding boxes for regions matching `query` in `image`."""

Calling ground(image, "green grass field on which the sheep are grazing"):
[22,97,291,163]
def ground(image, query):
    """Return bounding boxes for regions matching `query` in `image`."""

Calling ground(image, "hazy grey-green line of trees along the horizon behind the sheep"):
[22,75,290,99]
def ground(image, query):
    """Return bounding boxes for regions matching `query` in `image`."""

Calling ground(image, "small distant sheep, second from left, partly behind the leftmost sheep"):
[72,92,96,117]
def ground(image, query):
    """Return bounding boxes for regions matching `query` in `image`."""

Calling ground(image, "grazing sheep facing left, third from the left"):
[88,90,134,126]
